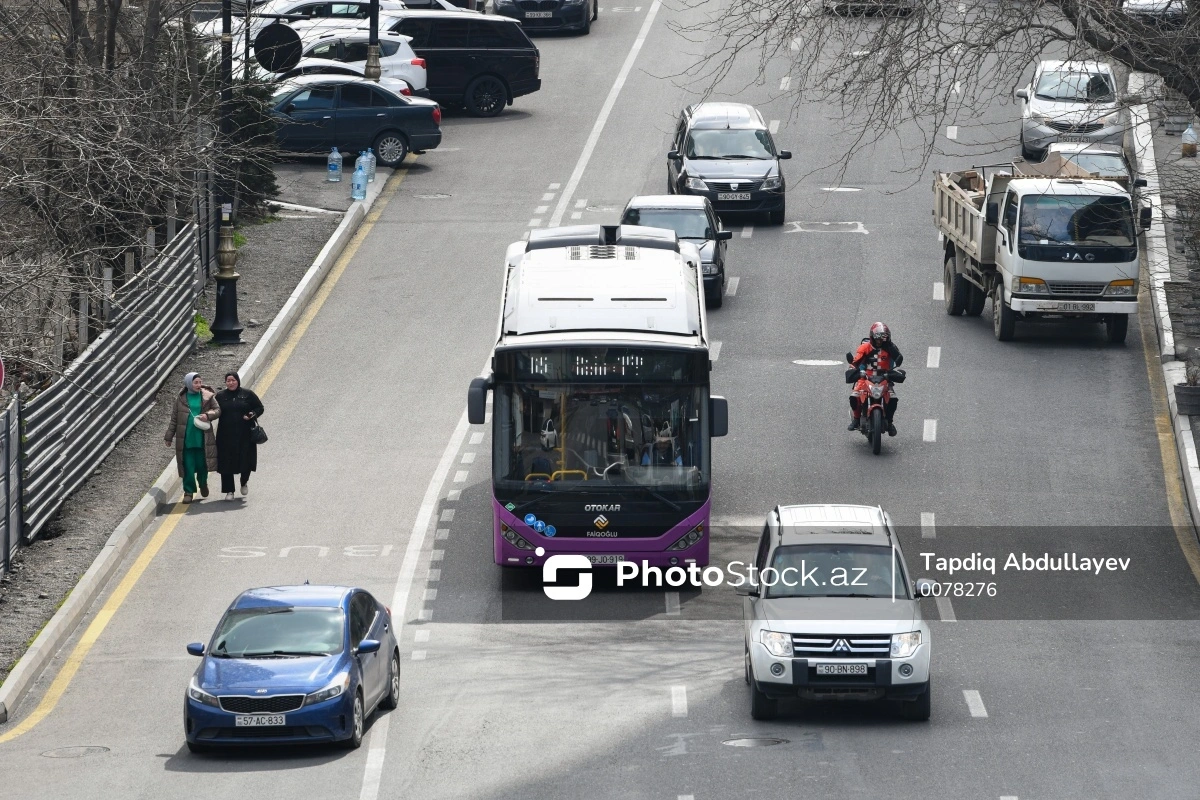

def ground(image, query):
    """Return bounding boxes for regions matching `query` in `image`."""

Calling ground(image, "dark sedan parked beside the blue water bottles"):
[271,74,442,167]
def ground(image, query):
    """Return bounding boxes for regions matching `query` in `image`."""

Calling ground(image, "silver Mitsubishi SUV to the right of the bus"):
[738,505,931,720]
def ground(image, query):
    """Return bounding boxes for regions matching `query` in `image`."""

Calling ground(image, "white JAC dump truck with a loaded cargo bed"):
[934,162,1150,343]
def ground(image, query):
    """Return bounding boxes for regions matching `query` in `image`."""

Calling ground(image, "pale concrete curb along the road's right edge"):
[1129,72,1200,528]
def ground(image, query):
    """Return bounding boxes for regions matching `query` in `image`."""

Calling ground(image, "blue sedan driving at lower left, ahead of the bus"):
[184,585,400,752]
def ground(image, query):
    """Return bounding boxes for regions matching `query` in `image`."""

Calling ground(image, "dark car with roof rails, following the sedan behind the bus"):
[667,103,792,225]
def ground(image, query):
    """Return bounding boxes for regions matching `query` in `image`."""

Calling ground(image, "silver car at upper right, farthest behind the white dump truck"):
[1015,61,1124,161]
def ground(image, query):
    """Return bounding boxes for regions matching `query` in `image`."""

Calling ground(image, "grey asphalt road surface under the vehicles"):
[7,0,1200,800]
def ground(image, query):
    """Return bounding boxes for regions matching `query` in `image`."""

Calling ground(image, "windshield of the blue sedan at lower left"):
[209,606,346,658]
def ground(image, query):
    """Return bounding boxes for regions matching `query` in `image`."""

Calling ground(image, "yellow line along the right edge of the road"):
[1138,279,1200,583]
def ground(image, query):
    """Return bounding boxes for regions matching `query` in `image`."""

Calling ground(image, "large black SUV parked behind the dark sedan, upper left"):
[389,11,541,116]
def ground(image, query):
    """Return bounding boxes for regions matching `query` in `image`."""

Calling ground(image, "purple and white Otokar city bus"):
[467,225,728,567]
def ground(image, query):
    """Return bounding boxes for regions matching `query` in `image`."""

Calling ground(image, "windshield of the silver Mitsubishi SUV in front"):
[761,545,910,600]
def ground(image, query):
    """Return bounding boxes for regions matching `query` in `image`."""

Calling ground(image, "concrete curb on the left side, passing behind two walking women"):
[0,169,391,723]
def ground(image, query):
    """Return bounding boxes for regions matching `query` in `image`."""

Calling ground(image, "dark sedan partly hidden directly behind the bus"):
[620,194,733,308]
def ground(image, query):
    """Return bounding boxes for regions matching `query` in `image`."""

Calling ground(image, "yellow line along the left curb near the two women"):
[0,168,408,745]
